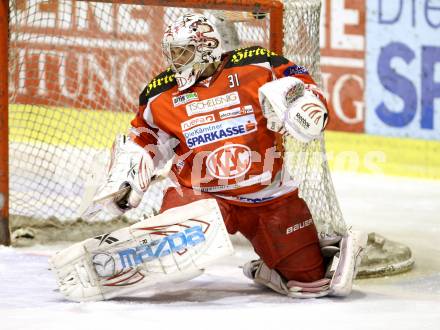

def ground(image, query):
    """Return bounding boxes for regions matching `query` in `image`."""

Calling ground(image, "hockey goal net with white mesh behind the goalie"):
[8,0,413,276]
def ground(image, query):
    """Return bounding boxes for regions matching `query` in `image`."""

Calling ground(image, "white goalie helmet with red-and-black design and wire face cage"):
[162,14,222,90]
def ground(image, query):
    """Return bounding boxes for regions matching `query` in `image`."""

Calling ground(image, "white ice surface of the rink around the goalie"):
[0,174,440,330]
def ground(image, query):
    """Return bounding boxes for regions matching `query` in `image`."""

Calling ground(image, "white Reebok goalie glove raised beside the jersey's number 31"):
[258,77,328,142]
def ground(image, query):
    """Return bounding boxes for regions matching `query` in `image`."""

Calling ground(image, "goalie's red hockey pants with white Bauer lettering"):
[161,187,324,282]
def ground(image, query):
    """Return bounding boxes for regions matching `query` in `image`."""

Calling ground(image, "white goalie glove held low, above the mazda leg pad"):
[93,134,154,216]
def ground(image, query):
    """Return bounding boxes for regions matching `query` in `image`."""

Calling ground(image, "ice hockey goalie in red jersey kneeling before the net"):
[52,14,366,301]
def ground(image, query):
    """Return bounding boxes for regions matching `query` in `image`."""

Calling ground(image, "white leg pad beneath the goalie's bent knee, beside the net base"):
[243,231,367,298]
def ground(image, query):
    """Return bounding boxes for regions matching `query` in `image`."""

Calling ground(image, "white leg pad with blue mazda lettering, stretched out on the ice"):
[49,199,233,301]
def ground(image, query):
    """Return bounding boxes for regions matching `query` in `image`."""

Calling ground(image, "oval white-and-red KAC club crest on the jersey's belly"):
[206,144,252,179]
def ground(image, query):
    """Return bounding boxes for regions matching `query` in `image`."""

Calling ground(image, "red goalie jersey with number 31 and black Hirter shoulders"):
[131,46,325,202]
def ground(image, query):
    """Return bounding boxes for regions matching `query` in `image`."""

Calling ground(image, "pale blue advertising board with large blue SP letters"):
[365,0,440,140]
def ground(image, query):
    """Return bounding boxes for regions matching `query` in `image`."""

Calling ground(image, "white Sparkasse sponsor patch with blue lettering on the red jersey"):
[183,114,257,149]
